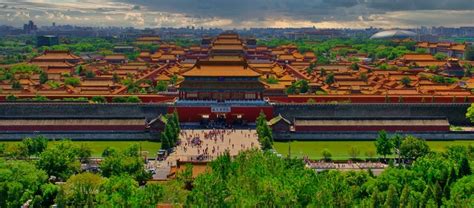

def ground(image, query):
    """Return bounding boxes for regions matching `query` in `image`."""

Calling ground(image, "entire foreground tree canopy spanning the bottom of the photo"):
[0,138,474,208]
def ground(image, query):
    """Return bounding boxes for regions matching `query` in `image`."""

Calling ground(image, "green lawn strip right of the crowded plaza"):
[273,140,474,160]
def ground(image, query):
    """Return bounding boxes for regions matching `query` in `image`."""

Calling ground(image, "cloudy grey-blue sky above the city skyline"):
[0,0,474,28]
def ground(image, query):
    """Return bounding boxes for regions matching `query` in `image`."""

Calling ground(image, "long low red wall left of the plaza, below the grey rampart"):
[0,125,146,131]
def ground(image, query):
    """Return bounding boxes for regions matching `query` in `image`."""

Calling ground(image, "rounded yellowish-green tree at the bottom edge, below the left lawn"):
[59,172,105,207]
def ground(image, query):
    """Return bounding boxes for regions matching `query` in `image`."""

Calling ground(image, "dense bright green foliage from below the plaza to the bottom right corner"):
[187,147,474,207]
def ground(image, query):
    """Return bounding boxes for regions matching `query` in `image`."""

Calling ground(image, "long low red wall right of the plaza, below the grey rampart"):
[295,126,449,132]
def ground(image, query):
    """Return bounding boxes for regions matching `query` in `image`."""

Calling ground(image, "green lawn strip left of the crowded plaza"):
[0,141,161,157]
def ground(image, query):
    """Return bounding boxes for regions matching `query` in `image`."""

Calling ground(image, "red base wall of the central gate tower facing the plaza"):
[168,106,273,122]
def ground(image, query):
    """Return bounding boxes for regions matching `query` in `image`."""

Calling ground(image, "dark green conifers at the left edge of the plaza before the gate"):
[160,110,181,150]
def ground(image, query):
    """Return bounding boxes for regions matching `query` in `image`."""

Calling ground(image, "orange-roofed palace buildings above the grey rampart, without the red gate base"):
[0,33,474,102]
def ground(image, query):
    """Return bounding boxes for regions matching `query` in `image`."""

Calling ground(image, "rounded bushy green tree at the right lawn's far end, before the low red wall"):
[400,136,430,160]
